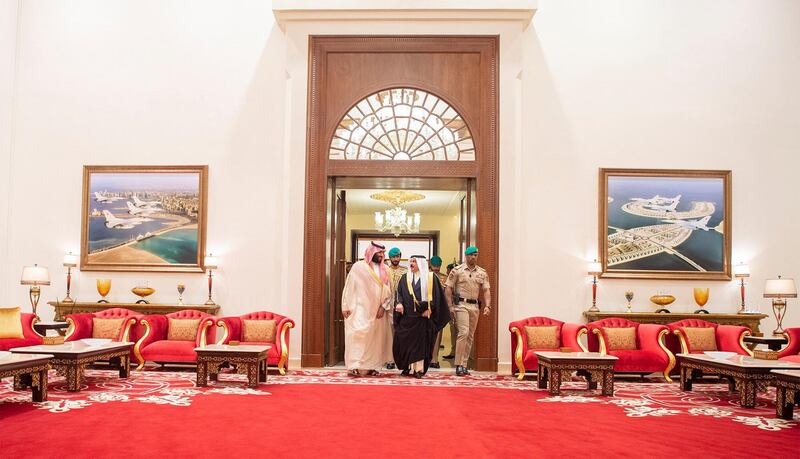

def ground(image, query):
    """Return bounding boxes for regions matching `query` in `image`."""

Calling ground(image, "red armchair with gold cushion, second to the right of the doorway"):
[586,317,675,382]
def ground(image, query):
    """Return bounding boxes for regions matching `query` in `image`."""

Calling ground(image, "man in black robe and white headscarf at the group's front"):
[392,255,450,378]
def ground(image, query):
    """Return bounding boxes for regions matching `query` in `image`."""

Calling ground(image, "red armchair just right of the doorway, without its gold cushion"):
[508,317,587,381]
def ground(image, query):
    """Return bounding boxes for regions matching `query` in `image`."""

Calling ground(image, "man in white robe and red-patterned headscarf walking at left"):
[342,242,392,376]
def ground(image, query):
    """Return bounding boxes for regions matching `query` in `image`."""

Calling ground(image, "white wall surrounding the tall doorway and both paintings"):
[0,0,800,370]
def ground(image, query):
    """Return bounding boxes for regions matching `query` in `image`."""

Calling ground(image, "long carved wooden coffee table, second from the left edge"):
[9,341,133,392]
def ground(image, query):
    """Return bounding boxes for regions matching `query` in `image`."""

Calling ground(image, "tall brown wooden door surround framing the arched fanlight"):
[301,36,502,371]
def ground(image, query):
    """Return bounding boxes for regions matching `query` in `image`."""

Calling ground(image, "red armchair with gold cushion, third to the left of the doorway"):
[64,308,144,364]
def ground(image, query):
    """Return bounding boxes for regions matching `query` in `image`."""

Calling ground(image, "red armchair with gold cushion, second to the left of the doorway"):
[133,309,217,370]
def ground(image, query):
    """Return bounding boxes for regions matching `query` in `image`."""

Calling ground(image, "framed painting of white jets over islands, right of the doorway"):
[598,169,731,280]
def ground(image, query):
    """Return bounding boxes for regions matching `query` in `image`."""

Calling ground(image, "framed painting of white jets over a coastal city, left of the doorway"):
[81,166,208,272]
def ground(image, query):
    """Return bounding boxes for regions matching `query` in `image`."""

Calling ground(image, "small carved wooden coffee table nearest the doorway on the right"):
[535,351,617,395]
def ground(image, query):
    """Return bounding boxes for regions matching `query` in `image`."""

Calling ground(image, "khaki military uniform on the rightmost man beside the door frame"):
[447,263,489,367]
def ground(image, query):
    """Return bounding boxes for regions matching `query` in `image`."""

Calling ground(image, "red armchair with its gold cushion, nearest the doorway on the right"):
[508,317,587,381]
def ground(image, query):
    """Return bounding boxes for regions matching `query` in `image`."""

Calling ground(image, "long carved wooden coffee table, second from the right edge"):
[676,354,800,408]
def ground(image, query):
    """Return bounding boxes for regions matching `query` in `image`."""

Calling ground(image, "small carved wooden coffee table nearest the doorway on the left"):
[194,344,272,387]
